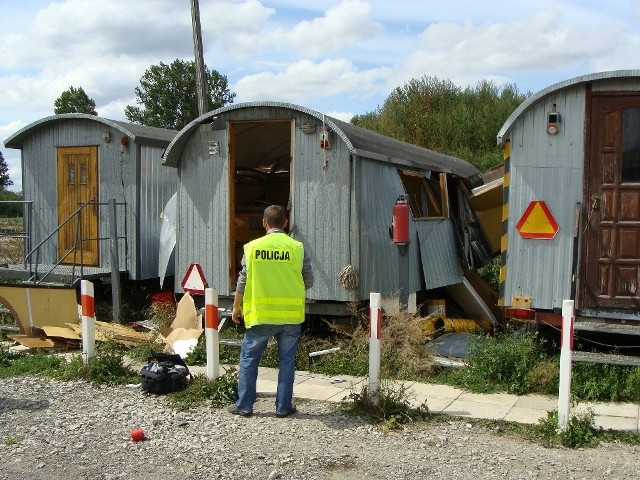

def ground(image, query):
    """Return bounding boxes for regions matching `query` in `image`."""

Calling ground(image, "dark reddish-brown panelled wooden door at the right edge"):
[580,95,640,308]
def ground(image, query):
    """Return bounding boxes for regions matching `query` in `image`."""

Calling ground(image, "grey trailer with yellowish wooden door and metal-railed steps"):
[0,113,177,283]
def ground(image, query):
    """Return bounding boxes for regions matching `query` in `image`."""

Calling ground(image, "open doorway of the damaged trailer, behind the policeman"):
[229,120,293,285]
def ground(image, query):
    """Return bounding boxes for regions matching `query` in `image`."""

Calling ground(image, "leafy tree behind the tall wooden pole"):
[124,59,236,130]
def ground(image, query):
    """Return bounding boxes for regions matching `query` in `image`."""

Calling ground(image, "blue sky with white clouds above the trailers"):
[0,0,640,191]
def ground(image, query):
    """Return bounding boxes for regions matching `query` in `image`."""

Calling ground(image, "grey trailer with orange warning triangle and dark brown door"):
[497,70,640,331]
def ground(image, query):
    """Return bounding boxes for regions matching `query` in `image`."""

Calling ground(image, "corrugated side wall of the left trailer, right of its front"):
[138,145,177,280]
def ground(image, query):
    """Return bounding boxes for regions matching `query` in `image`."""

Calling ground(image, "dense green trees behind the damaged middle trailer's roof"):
[351,76,529,171]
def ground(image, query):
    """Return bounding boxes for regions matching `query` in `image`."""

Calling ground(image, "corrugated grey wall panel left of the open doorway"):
[175,125,230,295]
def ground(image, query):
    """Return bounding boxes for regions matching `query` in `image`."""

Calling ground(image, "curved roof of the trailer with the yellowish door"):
[4,113,178,148]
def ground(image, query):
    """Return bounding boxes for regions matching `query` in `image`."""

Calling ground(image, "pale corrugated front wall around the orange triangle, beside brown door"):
[505,84,585,309]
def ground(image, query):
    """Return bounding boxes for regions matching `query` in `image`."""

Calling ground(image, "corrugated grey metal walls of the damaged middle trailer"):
[176,106,470,302]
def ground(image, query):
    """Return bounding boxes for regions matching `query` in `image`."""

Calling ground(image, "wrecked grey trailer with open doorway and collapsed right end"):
[164,101,495,322]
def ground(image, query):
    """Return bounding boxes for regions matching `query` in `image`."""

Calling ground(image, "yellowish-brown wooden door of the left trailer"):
[57,147,99,265]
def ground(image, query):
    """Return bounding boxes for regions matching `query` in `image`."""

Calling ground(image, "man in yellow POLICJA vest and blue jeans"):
[229,205,314,418]
